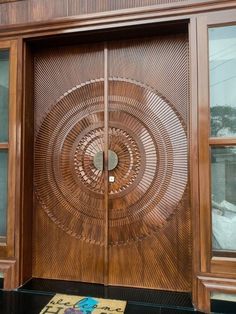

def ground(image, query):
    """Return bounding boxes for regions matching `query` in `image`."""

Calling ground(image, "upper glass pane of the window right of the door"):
[209,26,236,137]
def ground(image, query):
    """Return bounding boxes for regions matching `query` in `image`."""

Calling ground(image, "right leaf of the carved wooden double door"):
[108,35,191,291]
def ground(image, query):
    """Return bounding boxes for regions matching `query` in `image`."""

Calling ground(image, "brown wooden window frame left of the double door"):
[0,40,18,288]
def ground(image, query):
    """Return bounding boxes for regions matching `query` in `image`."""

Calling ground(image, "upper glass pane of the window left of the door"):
[0,49,9,142]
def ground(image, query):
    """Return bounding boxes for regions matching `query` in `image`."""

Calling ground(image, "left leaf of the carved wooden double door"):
[33,44,105,283]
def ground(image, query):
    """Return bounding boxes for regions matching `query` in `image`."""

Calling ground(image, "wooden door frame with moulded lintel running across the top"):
[0,1,236,309]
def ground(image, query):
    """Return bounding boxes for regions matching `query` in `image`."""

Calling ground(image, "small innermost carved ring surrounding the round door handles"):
[74,127,141,195]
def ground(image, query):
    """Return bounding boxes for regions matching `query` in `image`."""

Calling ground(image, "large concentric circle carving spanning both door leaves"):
[35,78,188,245]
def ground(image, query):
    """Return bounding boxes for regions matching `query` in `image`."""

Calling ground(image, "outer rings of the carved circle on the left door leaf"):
[34,79,104,244]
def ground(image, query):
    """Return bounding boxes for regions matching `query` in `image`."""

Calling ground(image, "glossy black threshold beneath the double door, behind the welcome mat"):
[18,278,194,312]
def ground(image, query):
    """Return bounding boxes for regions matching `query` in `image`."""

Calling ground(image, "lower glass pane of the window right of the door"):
[211,146,236,251]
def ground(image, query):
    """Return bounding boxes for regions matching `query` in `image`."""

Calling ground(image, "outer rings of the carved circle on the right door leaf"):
[109,78,188,245]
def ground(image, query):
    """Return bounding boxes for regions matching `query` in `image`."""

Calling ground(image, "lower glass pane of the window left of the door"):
[0,150,8,238]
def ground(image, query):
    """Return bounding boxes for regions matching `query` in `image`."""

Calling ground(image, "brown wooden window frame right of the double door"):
[197,10,236,278]
